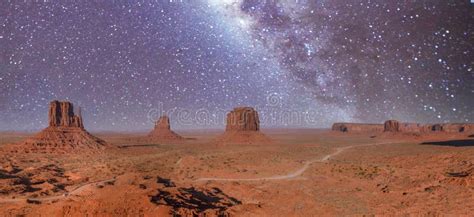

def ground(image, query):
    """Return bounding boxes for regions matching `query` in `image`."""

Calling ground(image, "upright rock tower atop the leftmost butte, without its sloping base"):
[49,100,84,128]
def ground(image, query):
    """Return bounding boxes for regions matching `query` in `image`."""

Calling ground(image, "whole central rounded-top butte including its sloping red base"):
[219,107,270,144]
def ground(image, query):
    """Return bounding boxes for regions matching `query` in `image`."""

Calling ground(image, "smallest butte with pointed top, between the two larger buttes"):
[148,116,184,142]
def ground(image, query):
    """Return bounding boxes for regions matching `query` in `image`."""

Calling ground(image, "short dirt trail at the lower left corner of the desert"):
[0,178,116,203]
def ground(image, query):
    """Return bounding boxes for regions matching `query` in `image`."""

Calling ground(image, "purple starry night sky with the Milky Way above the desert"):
[0,0,474,131]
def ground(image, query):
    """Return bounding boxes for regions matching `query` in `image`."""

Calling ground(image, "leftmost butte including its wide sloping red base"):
[12,101,108,153]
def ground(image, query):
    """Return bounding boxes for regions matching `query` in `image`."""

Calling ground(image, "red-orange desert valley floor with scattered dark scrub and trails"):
[0,129,474,216]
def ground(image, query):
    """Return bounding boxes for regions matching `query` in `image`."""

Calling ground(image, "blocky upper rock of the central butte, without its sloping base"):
[226,107,260,132]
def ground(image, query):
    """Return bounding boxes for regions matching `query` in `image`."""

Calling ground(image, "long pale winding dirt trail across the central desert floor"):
[194,142,392,182]
